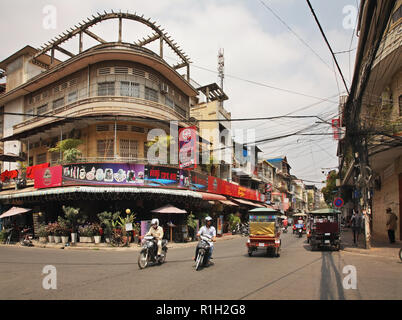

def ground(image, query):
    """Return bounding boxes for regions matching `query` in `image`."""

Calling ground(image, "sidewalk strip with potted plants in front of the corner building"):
[0,234,241,251]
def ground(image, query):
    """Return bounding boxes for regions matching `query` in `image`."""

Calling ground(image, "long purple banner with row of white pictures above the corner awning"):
[63,163,144,186]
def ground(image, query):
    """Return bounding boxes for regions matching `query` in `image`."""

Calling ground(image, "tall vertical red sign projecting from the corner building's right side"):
[179,126,198,169]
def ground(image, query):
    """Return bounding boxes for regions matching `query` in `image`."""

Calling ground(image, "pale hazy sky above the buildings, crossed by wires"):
[0,0,358,186]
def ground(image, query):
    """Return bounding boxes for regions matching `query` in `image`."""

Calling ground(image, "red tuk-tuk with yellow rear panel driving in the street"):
[247,208,281,257]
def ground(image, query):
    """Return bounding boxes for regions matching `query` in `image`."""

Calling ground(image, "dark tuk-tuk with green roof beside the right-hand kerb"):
[307,209,341,251]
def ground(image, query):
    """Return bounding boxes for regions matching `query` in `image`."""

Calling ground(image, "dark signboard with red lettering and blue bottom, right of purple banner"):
[145,166,180,187]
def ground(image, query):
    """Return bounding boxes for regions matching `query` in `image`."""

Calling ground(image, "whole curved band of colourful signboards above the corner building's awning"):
[35,163,266,202]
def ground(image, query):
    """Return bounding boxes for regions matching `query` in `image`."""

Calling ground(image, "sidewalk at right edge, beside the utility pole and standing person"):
[341,228,402,261]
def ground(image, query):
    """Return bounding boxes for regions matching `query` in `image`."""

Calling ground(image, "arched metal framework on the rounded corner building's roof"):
[32,10,191,80]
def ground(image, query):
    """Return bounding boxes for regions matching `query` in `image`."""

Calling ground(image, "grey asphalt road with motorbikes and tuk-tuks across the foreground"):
[0,233,402,300]
